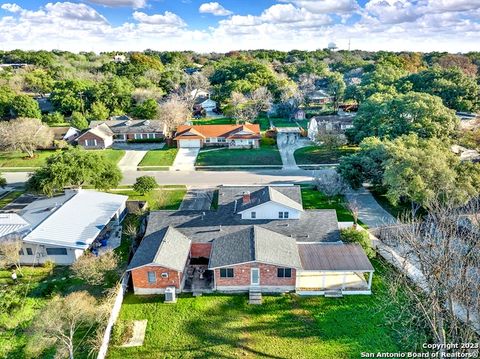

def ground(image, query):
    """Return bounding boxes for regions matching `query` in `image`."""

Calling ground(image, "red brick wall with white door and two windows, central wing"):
[214,263,296,292]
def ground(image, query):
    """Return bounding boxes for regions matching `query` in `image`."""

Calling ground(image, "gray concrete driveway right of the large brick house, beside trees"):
[346,188,397,228]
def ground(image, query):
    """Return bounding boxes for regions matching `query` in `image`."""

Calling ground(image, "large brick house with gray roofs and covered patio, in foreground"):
[128,185,374,295]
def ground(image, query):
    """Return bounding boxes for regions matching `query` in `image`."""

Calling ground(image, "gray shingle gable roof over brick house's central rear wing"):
[209,226,301,268]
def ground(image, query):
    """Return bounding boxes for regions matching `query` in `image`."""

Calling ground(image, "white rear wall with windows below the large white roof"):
[20,242,80,265]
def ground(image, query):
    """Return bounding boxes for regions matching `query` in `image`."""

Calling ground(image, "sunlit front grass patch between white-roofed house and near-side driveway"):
[111,188,187,211]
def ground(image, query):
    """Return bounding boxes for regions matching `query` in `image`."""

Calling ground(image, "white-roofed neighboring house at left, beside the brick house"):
[0,190,128,265]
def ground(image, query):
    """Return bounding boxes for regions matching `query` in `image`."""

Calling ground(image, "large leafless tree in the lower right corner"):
[378,201,480,344]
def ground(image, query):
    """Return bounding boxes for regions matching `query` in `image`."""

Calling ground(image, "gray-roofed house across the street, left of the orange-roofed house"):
[78,116,165,149]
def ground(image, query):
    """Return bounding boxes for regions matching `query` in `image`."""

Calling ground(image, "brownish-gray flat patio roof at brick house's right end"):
[298,243,374,272]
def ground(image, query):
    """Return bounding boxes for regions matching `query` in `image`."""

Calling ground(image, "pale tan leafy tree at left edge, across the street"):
[0,118,53,157]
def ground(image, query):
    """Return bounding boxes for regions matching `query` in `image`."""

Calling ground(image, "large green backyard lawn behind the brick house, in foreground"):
[107,260,424,359]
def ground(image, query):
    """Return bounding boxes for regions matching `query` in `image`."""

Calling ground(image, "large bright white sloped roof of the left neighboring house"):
[23,190,128,249]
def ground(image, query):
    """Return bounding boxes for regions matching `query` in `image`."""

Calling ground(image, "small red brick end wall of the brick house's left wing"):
[132,266,183,295]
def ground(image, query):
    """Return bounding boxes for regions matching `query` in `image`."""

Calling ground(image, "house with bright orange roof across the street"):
[174,123,261,148]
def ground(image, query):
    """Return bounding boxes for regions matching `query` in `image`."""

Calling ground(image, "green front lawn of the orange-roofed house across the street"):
[195,146,282,166]
